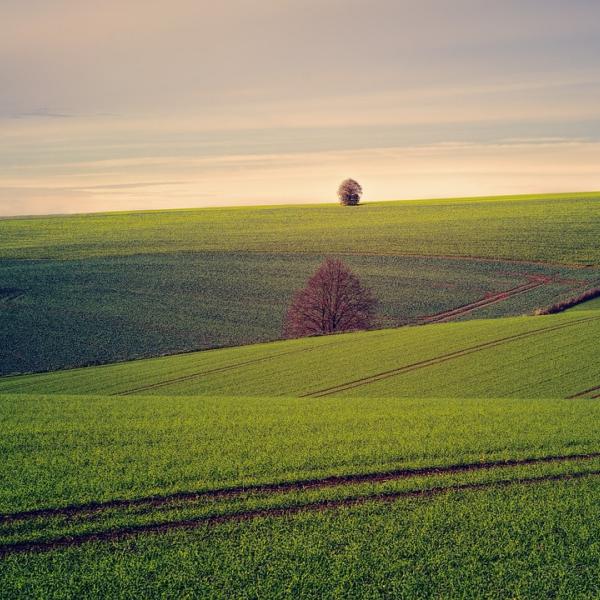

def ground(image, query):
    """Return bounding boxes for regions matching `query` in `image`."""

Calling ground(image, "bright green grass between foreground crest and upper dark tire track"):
[0,395,600,513]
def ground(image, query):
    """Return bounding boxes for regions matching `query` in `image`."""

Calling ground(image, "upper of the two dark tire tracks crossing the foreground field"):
[0,452,600,524]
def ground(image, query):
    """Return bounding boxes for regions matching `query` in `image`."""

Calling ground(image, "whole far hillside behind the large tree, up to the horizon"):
[0,194,600,375]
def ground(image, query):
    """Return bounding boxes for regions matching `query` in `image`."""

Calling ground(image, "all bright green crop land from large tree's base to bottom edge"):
[0,303,600,597]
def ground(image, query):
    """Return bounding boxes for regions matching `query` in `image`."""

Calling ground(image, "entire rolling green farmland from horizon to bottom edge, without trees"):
[0,195,600,599]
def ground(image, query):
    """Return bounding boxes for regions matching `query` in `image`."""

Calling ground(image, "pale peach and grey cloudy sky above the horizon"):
[0,0,600,216]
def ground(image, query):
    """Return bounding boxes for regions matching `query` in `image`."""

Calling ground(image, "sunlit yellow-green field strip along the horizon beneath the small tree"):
[0,192,600,265]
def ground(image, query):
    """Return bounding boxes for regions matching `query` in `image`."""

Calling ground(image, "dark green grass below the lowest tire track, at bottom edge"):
[0,477,600,599]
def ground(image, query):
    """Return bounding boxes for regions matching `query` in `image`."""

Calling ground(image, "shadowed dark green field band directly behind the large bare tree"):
[0,252,584,374]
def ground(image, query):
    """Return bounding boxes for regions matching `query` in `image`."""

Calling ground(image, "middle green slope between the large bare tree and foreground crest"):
[0,311,600,398]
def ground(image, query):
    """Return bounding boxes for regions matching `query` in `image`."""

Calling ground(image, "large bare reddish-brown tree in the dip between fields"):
[283,258,377,338]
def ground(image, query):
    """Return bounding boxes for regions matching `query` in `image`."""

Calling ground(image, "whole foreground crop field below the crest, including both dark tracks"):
[0,395,600,597]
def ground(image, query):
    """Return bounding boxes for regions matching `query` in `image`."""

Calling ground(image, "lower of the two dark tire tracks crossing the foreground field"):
[0,470,600,558]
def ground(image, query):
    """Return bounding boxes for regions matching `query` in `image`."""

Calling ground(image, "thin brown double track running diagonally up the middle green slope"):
[300,316,600,398]
